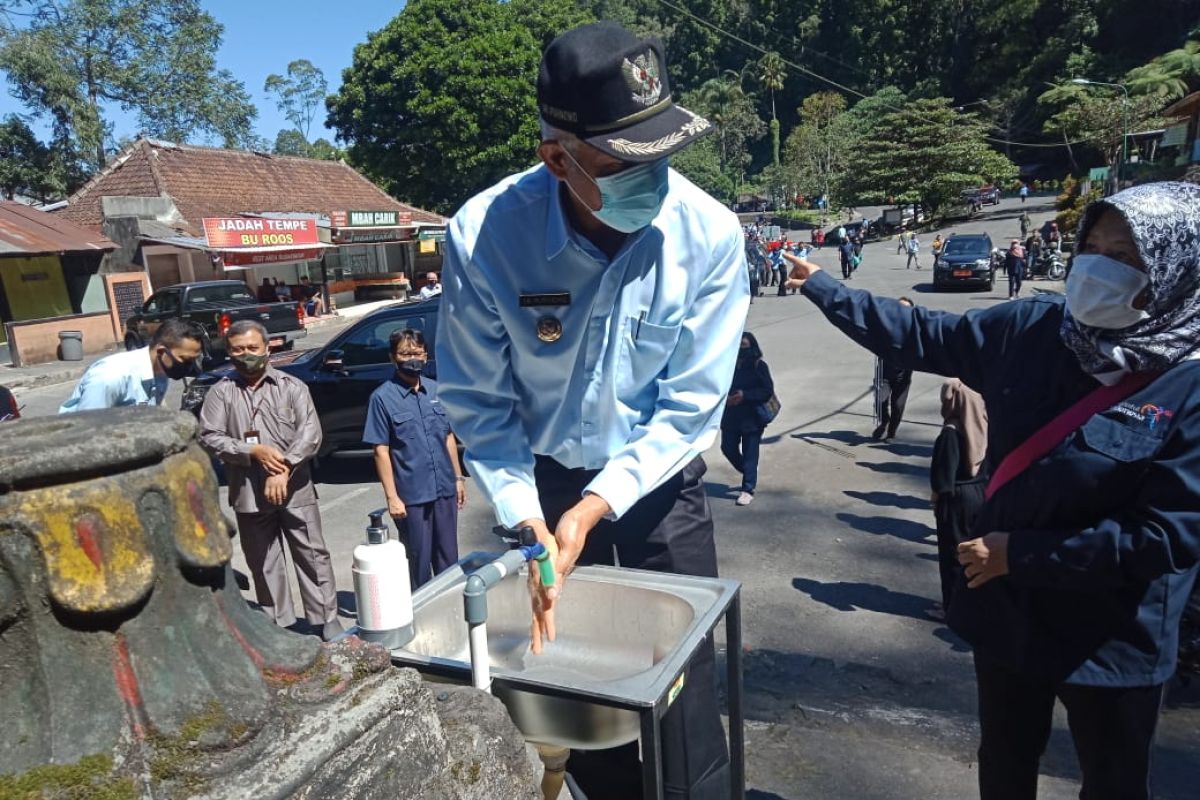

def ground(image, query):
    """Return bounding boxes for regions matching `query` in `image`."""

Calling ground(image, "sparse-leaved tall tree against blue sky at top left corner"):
[0,0,257,167]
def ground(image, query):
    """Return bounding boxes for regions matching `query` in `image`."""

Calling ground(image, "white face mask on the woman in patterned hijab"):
[1067,253,1150,331]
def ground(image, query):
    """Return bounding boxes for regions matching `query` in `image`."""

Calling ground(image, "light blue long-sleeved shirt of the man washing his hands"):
[437,166,750,527]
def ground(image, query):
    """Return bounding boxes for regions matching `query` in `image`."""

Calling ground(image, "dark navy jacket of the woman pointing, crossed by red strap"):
[804,272,1200,686]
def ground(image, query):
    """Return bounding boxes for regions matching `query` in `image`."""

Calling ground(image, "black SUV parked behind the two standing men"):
[182,297,440,456]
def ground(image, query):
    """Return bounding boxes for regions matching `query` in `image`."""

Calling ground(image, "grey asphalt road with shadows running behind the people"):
[11,199,1200,800]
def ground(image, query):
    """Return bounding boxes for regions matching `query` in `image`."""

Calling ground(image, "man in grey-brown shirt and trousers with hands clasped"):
[200,320,342,642]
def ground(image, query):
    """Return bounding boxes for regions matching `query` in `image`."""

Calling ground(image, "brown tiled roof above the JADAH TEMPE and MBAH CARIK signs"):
[58,139,446,233]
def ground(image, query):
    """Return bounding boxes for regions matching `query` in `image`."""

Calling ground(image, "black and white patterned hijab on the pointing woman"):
[1060,181,1200,383]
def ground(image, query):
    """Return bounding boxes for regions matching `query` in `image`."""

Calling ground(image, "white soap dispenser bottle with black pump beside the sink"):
[352,509,415,650]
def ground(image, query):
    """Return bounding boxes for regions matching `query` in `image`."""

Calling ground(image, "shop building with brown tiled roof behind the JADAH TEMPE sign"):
[56,138,446,305]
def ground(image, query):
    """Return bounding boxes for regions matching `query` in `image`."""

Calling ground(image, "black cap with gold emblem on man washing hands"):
[538,22,713,162]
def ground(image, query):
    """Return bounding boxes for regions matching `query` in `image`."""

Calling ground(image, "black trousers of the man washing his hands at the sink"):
[534,457,730,800]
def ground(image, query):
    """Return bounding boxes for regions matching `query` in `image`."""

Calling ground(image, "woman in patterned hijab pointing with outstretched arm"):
[792,182,1200,800]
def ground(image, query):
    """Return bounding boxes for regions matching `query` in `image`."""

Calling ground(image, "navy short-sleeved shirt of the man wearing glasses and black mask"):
[362,378,457,505]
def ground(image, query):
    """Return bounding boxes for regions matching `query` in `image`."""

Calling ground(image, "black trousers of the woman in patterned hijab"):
[974,652,1163,800]
